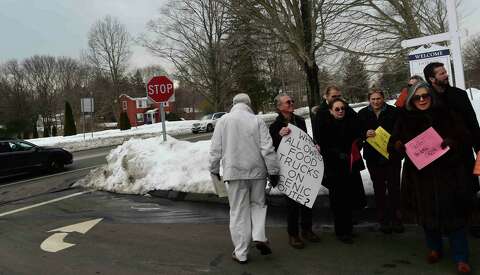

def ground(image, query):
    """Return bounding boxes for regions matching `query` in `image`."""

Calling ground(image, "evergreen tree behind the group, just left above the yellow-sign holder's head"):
[342,54,369,103]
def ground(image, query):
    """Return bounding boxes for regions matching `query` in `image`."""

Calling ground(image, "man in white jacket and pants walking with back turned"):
[210,93,280,263]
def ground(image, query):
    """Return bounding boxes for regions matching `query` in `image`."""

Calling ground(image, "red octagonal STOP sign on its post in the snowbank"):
[147,76,173,141]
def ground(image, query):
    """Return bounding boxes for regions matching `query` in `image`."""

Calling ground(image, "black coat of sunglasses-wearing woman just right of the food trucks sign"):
[316,111,366,209]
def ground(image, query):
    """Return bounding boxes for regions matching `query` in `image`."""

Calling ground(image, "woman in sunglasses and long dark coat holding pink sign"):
[389,82,473,274]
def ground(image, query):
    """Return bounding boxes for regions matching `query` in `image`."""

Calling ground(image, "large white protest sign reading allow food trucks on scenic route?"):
[277,124,324,208]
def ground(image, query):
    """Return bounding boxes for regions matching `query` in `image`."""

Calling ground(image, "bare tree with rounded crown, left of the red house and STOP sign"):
[87,15,131,117]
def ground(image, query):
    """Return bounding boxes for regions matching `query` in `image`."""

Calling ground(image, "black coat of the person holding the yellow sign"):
[358,104,399,165]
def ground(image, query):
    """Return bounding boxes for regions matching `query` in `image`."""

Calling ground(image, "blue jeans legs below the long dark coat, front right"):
[423,227,468,263]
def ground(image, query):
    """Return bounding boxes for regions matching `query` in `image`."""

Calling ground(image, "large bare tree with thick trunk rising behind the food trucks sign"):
[234,0,354,115]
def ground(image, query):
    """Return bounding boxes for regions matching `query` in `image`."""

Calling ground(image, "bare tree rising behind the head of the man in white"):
[141,0,232,110]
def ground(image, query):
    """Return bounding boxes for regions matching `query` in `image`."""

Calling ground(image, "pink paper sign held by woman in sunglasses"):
[405,127,450,170]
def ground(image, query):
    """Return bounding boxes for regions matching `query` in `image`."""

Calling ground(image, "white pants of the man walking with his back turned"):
[228,179,267,261]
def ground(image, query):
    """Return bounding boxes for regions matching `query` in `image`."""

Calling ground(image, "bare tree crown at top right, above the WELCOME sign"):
[328,0,447,59]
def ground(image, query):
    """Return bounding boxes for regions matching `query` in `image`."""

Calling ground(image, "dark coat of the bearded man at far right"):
[435,87,480,193]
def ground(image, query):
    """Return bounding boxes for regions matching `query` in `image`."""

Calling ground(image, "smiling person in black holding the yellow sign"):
[358,88,405,234]
